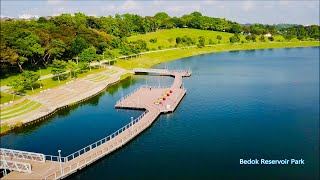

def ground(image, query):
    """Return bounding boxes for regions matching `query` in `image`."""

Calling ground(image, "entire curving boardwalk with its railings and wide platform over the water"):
[0,69,191,180]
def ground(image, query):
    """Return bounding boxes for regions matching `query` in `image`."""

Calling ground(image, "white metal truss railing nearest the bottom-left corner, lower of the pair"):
[0,159,32,174]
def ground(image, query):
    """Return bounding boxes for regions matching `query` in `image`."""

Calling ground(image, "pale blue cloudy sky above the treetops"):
[1,0,319,25]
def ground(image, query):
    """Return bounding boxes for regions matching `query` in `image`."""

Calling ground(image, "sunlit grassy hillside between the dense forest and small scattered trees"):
[128,28,284,50]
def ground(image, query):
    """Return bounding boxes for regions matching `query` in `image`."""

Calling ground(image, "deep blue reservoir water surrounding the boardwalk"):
[1,47,319,180]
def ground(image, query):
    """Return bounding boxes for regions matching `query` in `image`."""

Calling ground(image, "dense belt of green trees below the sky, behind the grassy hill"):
[0,12,319,75]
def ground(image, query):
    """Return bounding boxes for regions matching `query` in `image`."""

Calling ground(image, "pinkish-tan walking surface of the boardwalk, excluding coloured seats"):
[1,68,191,179]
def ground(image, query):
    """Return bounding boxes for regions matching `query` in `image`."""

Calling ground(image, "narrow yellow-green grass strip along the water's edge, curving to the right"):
[116,41,320,69]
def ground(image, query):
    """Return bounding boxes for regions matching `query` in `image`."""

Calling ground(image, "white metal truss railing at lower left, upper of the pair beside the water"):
[0,148,46,162]
